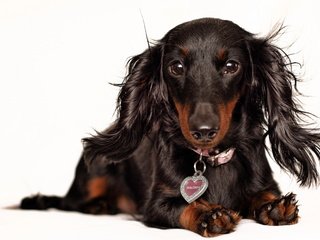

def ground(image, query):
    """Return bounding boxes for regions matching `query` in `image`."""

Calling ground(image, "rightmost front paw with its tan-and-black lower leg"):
[250,192,299,225]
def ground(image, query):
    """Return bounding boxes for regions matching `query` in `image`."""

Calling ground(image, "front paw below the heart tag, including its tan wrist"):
[180,201,241,237]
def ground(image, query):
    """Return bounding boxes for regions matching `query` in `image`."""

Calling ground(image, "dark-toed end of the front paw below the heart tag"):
[198,207,241,237]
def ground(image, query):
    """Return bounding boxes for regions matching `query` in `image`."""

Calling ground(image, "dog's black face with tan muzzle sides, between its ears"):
[162,19,250,151]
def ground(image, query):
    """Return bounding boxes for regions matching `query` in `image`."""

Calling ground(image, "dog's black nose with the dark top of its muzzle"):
[189,103,219,142]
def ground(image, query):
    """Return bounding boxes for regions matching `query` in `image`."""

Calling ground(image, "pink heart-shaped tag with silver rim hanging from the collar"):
[180,175,208,203]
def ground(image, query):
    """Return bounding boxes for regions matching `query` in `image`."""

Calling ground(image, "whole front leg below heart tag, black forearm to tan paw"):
[144,196,241,237]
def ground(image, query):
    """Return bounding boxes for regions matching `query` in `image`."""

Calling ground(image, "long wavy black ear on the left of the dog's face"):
[83,43,167,165]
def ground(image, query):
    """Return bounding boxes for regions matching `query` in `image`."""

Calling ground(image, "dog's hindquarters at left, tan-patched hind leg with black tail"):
[20,155,136,214]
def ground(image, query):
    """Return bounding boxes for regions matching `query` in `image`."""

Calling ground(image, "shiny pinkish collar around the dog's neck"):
[192,148,236,167]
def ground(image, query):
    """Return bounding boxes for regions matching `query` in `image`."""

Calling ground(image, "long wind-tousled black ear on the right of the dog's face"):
[249,29,320,186]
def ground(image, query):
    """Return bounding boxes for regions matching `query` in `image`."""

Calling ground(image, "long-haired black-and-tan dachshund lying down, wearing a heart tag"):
[20,18,320,237]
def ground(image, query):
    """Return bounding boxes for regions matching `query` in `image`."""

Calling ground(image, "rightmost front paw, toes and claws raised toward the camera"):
[253,193,299,225]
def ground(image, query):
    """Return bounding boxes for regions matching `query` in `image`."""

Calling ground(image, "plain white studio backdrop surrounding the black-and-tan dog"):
[0,0,320,239]
